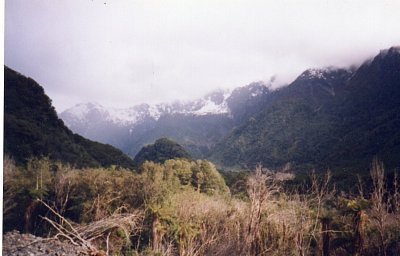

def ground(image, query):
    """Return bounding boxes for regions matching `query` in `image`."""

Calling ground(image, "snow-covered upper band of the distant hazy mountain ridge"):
[60,82,269,129]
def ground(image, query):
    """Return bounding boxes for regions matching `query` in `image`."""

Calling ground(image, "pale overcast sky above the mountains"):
[5,0,400,111]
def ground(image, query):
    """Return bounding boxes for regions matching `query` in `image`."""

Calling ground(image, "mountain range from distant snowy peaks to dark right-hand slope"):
[10,47,400,171]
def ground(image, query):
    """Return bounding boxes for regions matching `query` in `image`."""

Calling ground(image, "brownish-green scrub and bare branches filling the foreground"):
[3,157,400,255]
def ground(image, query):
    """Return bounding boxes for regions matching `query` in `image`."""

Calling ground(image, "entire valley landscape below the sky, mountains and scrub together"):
[3,47,400,256]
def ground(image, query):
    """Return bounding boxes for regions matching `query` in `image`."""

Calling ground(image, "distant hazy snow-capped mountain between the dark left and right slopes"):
[60,82,271,156]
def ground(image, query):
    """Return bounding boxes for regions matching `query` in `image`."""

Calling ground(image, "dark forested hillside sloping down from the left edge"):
[4,67,134,168]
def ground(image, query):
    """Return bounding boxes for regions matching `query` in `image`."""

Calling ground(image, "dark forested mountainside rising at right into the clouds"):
[211,48,400,170]
